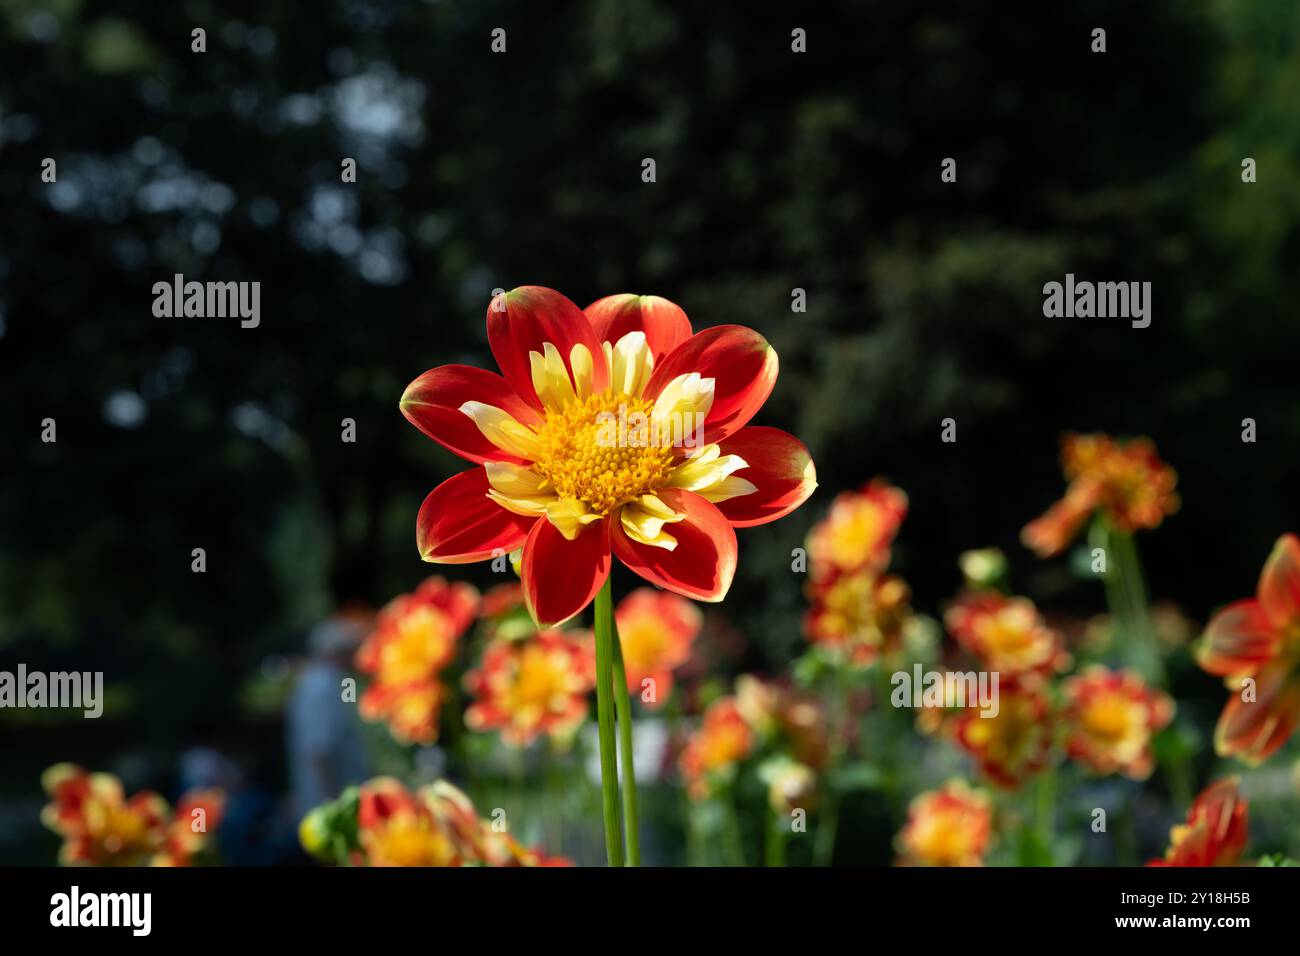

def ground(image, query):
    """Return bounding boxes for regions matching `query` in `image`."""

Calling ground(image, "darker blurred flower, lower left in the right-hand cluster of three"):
[952,678,1056,790]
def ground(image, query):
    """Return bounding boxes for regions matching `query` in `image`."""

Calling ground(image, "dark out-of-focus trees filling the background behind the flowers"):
[0,0,1300,864]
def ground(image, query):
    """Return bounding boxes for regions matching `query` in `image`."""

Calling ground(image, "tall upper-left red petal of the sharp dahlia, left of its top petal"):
[488,285,610,408]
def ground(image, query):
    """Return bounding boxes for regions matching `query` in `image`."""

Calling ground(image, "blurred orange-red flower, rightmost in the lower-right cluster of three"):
[1063,665,1174,780]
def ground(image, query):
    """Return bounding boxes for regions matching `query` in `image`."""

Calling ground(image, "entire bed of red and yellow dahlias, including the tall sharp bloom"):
[44,287,1300,866]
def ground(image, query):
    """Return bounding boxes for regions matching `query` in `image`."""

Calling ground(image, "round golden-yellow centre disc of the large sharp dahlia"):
[533,389,673,515]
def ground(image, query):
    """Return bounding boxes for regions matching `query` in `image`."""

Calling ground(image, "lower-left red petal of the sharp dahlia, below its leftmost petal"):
[415,468,538,564]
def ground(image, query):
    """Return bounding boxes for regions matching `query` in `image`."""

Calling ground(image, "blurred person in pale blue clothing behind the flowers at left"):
[285,613,368,819]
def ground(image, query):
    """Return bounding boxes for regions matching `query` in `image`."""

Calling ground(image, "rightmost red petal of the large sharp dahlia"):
[718,425,816,528]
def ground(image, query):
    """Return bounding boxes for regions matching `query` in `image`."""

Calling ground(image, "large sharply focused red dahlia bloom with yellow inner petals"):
[402,286,816,627]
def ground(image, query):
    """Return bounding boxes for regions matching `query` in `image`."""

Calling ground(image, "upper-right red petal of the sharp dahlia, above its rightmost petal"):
[645,325,777,442]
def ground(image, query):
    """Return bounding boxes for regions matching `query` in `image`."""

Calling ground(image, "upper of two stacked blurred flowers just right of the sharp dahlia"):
[809,479,907,574]
